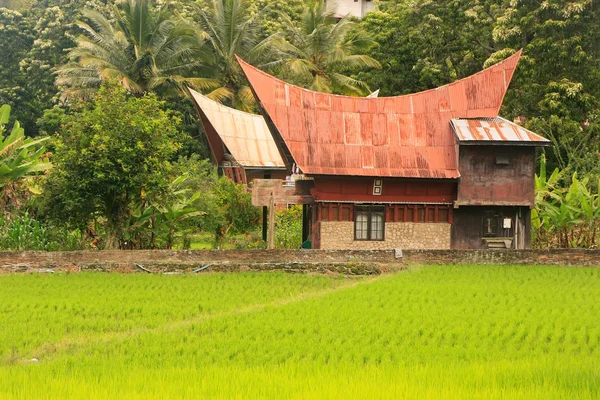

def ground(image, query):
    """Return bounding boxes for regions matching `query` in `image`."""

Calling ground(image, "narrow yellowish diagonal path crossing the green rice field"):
[0,275,392,366]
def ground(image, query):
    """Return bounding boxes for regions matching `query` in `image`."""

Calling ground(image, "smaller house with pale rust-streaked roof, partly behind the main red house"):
[190,89,287,184]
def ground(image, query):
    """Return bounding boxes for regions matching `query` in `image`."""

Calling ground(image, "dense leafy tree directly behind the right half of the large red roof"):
[358,0,502,96]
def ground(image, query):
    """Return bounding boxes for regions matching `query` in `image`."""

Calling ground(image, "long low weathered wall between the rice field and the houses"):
[0,249,600,275]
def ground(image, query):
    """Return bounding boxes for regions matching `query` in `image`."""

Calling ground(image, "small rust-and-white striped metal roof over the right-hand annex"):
[450,117,550,146]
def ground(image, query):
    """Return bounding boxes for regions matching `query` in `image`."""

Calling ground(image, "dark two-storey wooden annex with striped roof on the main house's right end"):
[450,117,550,249]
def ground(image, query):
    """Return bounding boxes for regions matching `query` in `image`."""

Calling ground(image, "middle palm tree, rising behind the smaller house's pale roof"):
[198,0,277,111]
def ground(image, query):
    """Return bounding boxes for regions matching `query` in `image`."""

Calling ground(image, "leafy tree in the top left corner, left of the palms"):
[0,0,106,136]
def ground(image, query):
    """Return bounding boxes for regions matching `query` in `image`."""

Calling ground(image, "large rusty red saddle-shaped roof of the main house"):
[238,51,521,178]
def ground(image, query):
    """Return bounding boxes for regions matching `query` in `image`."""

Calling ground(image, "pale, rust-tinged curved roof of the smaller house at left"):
[190,89,285,168]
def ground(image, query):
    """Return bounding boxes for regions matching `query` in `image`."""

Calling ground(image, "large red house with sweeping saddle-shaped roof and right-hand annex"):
[239,52,549,249]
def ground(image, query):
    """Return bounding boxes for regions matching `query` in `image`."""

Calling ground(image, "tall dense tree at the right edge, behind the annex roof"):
[488,0,600,176]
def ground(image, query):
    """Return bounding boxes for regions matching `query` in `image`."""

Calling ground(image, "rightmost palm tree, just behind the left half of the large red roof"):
[273,0,381,96]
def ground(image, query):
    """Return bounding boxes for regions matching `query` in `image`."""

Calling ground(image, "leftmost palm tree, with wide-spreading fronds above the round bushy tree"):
[56,0,218,97]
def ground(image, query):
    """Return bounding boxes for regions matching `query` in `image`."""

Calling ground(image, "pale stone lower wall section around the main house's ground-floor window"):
[321,221,452,250]
